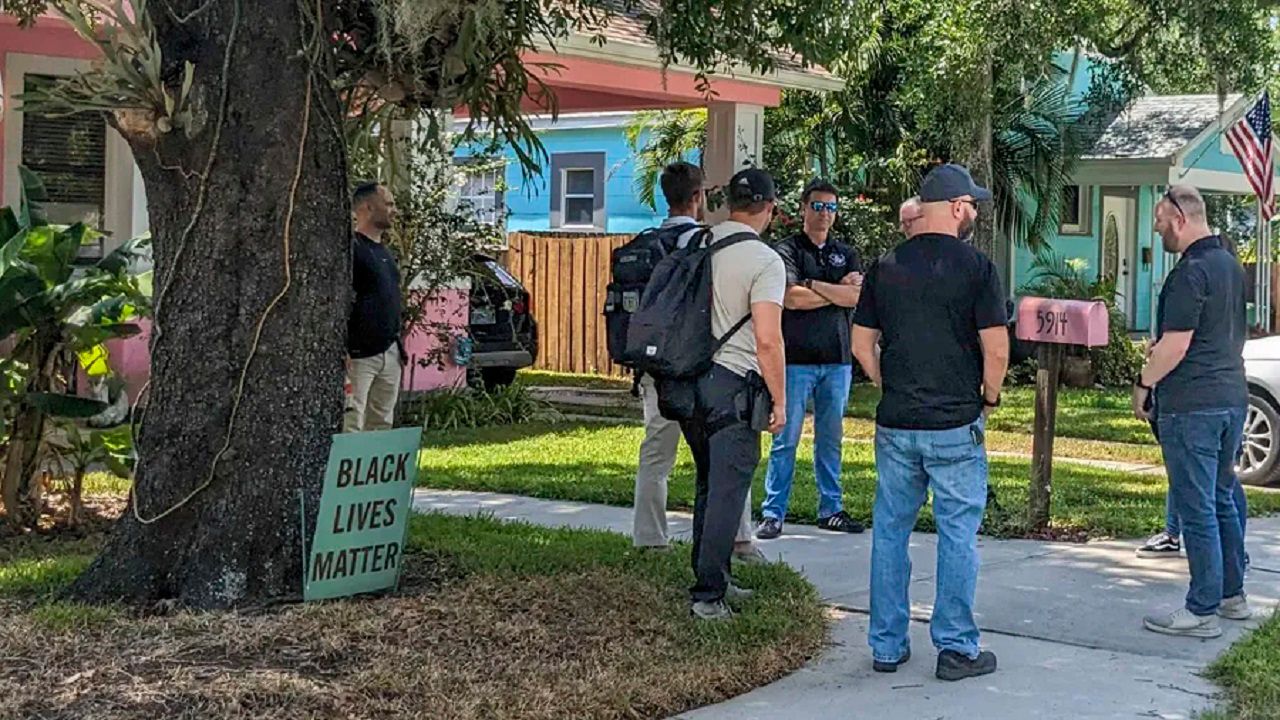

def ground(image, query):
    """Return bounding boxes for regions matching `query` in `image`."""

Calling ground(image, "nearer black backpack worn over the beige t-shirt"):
[622,231,763,384]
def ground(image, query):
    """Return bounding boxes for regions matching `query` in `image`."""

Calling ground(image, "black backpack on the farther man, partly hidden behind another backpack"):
[604,223,700,363]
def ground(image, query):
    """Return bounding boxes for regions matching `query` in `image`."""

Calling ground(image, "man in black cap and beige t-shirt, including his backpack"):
[623,168,787,620]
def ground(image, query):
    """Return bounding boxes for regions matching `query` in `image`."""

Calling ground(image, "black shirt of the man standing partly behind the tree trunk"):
[347,232,401,357]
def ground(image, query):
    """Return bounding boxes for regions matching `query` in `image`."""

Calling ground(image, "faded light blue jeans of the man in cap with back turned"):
[867,416,987,662]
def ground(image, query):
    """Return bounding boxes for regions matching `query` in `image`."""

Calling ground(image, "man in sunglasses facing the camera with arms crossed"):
[755,181,863,539]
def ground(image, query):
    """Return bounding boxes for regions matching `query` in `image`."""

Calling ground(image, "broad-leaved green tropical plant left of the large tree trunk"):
[0,168,150,527]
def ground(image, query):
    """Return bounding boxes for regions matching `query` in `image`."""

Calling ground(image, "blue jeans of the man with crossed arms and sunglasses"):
[760,365,854,520]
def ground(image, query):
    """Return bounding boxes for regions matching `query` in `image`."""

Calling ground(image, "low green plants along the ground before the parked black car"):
[403,384,561,430]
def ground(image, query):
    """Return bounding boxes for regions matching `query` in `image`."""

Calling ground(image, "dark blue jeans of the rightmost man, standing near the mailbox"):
[1158,407,1245,615]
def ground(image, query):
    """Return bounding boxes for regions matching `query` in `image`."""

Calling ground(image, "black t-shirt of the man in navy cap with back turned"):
[854,234,1007,430]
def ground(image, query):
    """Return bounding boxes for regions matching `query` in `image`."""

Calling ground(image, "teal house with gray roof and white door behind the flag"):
[1007,55,1257,334]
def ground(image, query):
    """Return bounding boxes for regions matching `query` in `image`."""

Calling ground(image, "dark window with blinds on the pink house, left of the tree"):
[19,74,106,260]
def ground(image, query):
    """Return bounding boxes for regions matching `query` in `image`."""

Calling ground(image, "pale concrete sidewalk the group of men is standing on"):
[415,489,1280,720]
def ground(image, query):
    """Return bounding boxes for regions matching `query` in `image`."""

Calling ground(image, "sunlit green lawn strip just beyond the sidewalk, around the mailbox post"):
[419,423,1280,538]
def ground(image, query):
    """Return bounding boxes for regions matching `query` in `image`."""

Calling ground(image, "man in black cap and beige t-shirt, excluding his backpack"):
[681,168,787,620]
